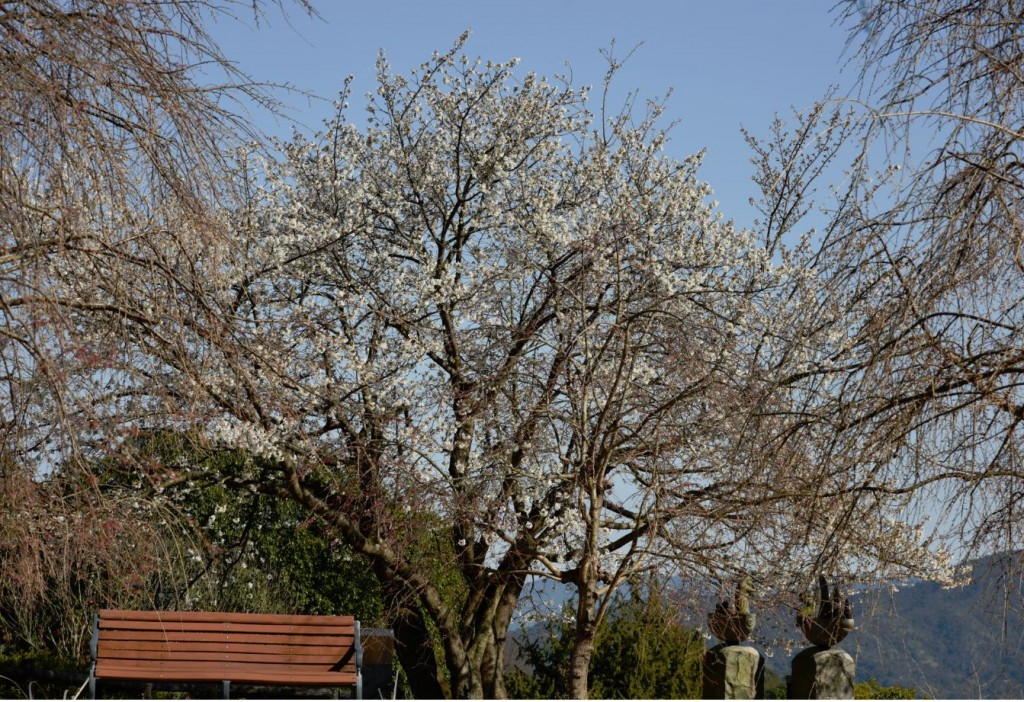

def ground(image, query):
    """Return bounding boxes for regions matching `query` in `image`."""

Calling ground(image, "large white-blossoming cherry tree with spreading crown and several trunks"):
[96,38,950,697]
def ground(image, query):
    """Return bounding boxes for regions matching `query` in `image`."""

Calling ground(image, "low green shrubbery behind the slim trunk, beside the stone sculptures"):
[506,594,705,699]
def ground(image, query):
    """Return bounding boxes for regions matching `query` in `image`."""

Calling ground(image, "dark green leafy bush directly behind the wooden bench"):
[102,434,382,626]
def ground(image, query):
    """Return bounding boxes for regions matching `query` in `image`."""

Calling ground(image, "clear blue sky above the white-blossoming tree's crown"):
[213,0,853,224]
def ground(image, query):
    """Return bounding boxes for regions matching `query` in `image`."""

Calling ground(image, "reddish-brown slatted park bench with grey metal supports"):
[89,609,362,699]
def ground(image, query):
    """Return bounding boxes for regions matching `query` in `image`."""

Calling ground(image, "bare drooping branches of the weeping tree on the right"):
[753,0,1024,558]
